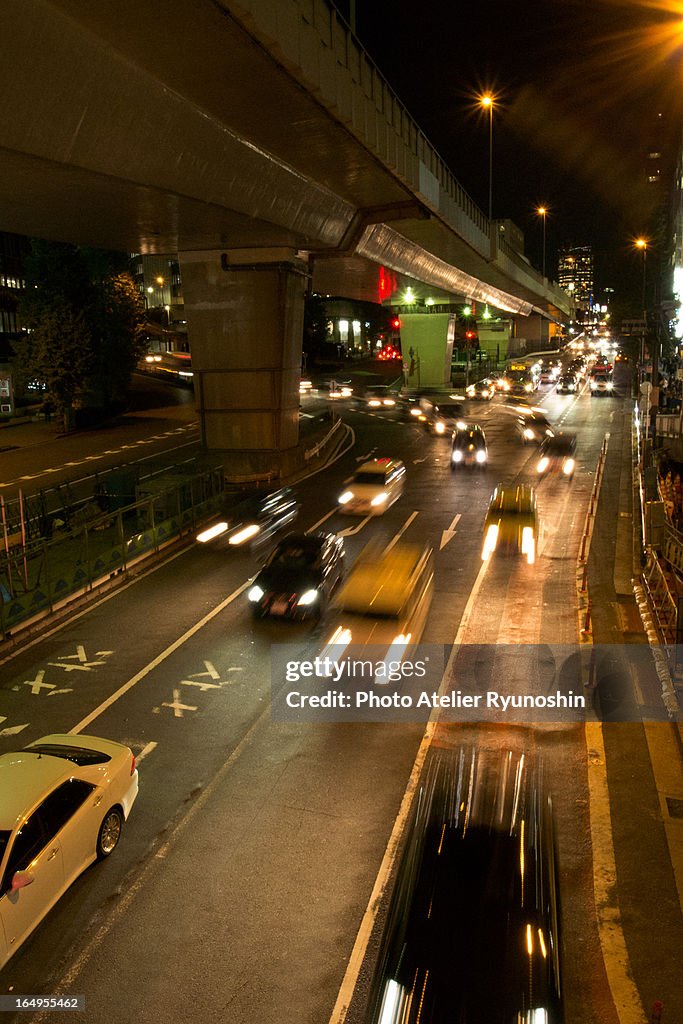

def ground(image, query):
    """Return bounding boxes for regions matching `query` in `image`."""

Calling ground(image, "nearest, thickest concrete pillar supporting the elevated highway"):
[179,249,308,475]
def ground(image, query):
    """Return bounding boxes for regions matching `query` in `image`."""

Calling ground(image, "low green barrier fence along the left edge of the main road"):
[0,467,225,639]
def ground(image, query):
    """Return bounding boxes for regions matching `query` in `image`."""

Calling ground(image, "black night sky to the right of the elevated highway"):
[337,0,683,302]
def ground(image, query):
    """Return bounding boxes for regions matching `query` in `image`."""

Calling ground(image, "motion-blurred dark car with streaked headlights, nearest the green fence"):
[197,487,299,548]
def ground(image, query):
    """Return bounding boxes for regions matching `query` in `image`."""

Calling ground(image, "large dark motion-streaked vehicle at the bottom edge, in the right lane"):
[366,750,563,1024]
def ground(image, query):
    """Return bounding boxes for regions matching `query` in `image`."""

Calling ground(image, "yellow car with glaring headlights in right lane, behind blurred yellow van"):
[481,483,539,565]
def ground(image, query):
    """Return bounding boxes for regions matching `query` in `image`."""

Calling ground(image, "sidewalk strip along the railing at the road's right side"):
[589,408,683,1024]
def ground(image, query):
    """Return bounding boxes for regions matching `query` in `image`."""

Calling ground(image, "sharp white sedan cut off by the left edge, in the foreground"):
[0,733,138,968]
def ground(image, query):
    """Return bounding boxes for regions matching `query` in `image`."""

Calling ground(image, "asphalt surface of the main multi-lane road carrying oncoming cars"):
[0,368,674,1024]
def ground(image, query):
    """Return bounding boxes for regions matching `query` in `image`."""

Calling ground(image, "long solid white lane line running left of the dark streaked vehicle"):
[330,561,488,1024]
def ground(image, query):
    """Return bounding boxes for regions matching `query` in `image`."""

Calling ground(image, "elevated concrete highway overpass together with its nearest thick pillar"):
[0,0,569,468]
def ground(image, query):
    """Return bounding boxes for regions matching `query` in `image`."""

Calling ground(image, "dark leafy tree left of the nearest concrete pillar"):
[14,240,144,429]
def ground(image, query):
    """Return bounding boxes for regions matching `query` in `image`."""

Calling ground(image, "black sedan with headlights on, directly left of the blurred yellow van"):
[247,534,344,618]
